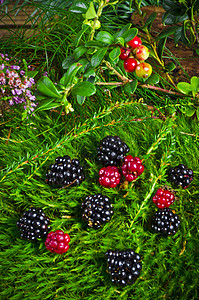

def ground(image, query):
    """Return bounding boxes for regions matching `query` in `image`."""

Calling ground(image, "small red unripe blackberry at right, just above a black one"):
[152,188,175,208]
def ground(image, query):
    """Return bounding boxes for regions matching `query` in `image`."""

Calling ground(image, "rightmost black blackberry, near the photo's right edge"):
[168,164,193,189]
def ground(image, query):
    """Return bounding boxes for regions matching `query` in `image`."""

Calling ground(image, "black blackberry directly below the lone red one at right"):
[151,207,180,235]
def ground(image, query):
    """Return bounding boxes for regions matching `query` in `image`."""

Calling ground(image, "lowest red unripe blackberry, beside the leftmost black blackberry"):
[45,230,70,254]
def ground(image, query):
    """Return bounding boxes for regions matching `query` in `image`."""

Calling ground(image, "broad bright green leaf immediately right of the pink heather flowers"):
[37,76,61,98]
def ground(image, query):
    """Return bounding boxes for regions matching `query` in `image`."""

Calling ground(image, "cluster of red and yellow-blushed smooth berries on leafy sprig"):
[119,36,152,78]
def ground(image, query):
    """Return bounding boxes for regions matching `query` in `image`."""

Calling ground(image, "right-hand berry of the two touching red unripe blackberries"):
[122,155,144,182]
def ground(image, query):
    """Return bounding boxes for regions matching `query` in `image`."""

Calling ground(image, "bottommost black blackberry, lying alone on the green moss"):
[105,249,142,285]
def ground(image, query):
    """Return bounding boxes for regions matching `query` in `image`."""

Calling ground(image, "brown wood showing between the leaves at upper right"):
[132,5,199,84]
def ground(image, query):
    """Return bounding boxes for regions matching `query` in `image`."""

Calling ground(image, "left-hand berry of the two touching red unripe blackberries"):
[99,166,121,188]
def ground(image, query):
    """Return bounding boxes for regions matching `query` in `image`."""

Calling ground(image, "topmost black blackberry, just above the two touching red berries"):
[97,135,129,167]
